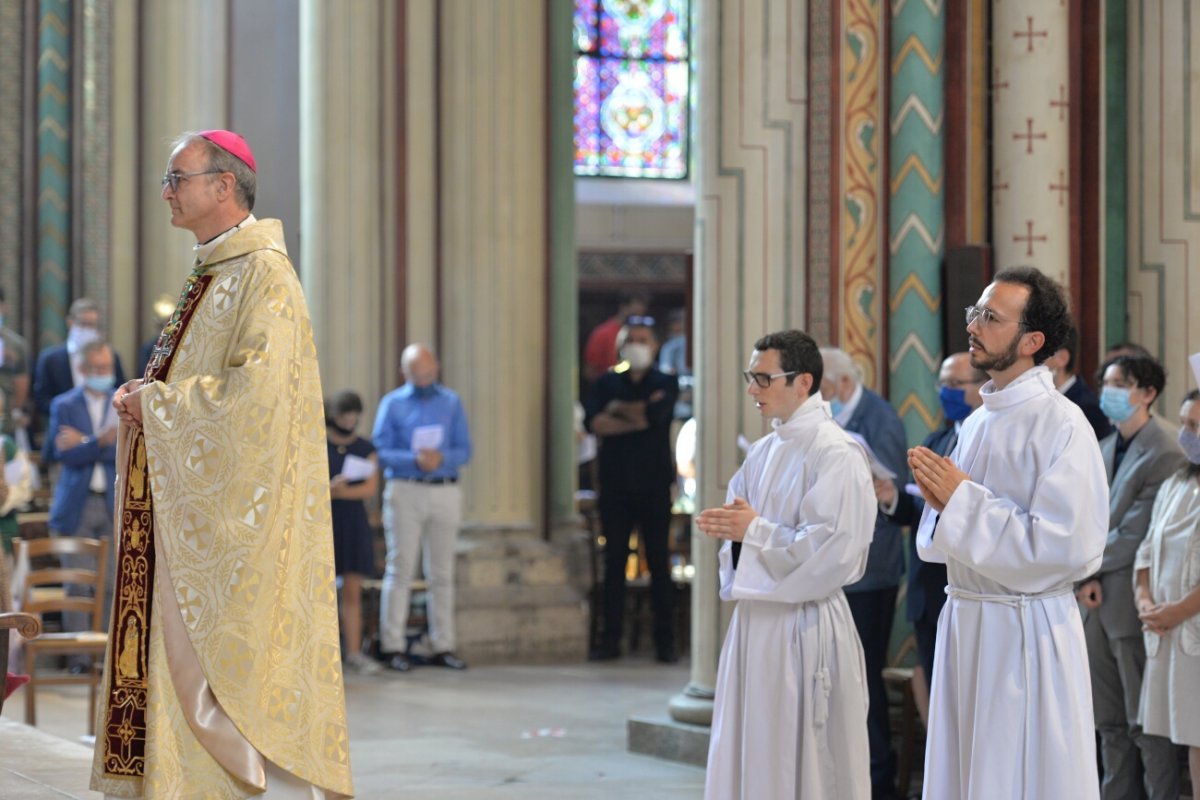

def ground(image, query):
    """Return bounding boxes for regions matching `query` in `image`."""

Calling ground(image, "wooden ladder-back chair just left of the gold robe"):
[13,536,108,734]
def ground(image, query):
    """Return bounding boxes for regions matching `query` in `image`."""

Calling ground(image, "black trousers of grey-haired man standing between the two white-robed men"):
[846,587,898,793]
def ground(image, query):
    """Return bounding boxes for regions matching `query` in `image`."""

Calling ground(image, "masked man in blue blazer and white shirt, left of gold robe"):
[42,341,118,631]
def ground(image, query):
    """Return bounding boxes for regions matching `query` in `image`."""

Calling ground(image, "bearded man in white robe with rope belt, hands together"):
[908,267,1109,800]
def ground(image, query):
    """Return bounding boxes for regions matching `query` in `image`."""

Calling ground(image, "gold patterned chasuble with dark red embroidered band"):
[91,219,353,800]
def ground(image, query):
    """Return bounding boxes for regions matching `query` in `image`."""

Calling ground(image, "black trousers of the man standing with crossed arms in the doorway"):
[600,486,674,650]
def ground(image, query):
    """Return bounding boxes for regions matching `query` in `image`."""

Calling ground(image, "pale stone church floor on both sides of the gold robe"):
[0,660,704,800]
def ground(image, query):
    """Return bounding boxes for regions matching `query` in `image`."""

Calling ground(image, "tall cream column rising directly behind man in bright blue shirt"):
[438,0,547,530]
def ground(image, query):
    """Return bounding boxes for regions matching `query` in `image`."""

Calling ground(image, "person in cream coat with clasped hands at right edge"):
[1134,390,1200,786]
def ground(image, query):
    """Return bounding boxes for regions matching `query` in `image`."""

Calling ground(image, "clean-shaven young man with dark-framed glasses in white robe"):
[696,331,876,800]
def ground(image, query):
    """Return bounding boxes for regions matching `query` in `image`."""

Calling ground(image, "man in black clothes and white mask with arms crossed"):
[584,315,679,663]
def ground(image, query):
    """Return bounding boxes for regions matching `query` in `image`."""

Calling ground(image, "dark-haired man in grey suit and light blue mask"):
[1076,355,1184,800]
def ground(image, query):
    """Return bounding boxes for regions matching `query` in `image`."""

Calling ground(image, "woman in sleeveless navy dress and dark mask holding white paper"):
[325,391,379,675]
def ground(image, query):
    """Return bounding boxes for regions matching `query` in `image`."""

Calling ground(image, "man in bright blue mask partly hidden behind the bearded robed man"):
[875,353,988,716]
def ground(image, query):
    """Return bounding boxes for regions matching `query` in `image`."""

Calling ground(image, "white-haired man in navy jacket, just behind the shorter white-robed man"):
[821,348,908,798]
